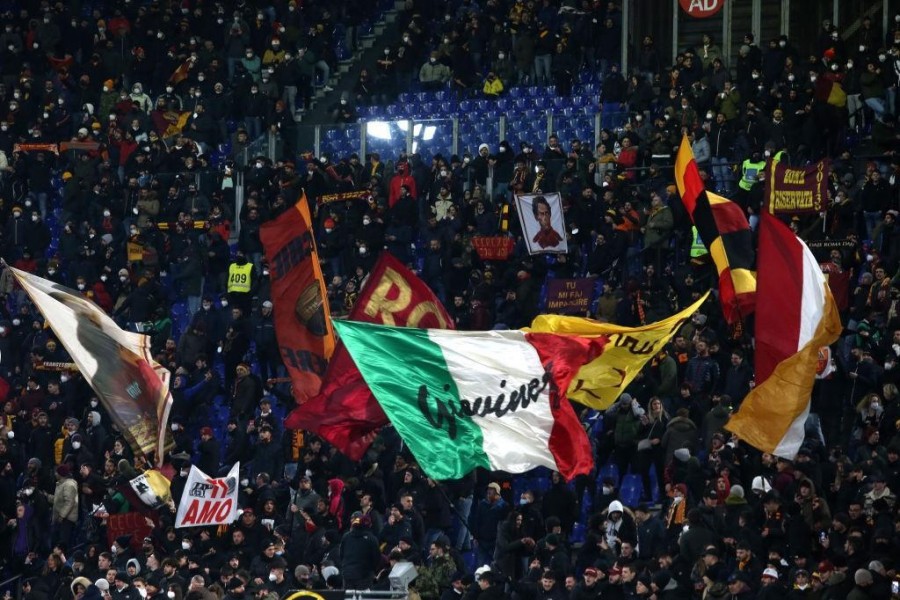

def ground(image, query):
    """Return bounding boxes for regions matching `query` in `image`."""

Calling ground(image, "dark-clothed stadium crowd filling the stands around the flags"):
[0,0,900,600]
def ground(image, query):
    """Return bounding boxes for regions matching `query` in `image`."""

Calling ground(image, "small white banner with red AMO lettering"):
[175,463,241,527]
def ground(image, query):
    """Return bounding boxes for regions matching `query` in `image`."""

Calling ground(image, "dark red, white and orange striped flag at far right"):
[726,212,841,459]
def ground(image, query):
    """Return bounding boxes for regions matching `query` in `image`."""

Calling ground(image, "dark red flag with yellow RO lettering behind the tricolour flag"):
[284,252,454,460]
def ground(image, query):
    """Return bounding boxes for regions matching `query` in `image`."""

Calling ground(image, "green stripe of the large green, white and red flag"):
[334,321,491,479]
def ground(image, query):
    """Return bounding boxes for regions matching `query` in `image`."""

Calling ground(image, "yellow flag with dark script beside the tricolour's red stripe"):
[530,292,709,410]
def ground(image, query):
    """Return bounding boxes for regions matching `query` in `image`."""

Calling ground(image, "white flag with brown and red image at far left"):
[7,267,172,463]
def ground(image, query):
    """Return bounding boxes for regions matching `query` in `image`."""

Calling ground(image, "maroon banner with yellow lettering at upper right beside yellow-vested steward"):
[765,159,831,215]
